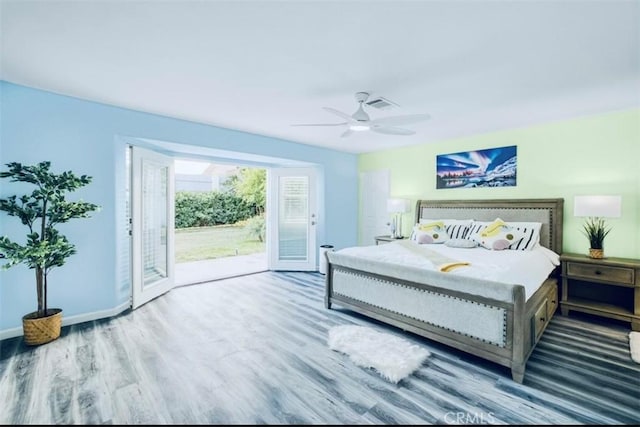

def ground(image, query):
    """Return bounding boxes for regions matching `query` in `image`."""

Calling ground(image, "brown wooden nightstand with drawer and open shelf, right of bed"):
[560,254,640,331]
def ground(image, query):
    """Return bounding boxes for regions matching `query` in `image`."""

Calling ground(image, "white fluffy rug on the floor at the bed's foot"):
[327,325,430,383]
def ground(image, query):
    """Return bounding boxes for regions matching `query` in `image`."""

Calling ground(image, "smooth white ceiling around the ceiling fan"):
[0,0,640,153]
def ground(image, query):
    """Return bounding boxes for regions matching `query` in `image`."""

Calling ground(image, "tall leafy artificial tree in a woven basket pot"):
[0,161,98,345]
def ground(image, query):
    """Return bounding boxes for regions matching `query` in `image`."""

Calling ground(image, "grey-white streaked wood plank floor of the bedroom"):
[0,272,640,424]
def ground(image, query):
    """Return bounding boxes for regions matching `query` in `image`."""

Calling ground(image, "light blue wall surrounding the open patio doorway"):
[0,81,358,336]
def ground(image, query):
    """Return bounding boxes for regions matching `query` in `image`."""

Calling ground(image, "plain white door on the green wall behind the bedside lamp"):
[360,169,391,246]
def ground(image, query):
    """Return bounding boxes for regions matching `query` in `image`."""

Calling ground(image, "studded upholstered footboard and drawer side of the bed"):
[325,261,557,383]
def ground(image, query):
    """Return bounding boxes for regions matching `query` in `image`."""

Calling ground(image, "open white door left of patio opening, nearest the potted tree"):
[131,146,175,309]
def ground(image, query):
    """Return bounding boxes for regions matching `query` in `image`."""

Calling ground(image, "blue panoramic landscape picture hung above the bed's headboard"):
[436,145,518,188]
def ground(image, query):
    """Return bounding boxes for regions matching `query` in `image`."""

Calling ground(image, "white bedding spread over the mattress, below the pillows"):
[337,240,560,299]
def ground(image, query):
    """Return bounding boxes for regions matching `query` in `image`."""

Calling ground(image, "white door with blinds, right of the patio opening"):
[267,168,318,271]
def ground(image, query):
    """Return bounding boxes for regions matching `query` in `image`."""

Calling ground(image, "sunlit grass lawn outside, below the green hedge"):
[175,225,266,263]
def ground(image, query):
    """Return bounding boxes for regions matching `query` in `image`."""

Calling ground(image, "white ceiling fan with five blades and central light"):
[291,92,430,138]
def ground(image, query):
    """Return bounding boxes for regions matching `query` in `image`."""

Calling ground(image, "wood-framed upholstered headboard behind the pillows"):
[415,199,564,254]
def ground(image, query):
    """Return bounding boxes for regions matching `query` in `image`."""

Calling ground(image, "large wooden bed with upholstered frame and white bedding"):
[324,199,563,383]
